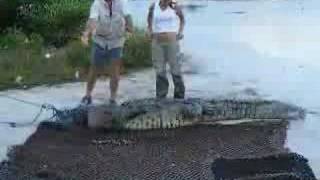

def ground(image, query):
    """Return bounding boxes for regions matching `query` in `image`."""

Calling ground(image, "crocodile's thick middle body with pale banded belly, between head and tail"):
[112,99,202,130]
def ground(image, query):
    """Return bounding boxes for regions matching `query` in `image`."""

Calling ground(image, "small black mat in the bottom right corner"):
[211,153,316,180]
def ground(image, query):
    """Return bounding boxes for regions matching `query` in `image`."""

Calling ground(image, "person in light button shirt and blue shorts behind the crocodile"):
[81,0,133,104]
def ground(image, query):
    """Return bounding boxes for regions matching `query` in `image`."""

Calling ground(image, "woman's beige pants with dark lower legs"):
[152,40,185,98]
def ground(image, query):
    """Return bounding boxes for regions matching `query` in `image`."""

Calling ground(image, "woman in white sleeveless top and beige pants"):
[147,0,185,99]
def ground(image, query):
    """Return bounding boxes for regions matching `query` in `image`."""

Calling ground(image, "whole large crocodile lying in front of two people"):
[47,98,305,130]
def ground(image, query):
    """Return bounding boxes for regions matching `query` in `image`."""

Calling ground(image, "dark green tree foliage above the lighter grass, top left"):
[0,0,92,46]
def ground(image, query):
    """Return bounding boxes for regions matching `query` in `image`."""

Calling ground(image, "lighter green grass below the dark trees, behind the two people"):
[0,30,151,90]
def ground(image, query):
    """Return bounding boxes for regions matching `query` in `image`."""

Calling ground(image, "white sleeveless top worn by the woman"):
[152,0,179,33]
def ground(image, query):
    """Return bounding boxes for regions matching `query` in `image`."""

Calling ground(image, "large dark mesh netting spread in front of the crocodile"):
[1,122,294,180]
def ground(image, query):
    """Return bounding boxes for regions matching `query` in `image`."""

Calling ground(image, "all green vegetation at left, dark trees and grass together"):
[0,0,151,89]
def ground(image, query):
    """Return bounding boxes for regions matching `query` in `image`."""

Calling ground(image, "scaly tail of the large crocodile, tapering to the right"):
[202,100,305,121]
